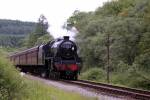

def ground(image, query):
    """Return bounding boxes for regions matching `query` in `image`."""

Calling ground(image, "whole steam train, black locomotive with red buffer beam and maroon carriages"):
[9,36,82,80]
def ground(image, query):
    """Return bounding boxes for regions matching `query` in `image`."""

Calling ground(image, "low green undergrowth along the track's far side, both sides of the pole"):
[80,66,150,90]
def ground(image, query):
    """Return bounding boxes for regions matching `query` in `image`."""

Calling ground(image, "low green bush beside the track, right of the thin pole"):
[111,64,150,90]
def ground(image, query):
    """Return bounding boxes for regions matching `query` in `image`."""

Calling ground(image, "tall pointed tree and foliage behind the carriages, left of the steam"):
[24,15,53,48]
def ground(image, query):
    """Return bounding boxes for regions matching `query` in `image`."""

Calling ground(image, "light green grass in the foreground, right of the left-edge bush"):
[24,80,96,100]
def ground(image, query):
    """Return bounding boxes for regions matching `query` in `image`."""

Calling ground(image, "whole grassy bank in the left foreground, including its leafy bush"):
[0,49,96,100]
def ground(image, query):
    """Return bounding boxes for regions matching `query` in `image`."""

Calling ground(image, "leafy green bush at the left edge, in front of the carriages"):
[0,53,26,100]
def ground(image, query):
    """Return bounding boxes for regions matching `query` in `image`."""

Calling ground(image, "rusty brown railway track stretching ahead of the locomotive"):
[63,80,150,100]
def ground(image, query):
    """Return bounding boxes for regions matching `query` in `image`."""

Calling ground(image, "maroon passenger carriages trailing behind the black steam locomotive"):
[10,46,43,72]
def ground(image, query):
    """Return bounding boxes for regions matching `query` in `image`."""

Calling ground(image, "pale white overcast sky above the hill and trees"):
[0,0,109,38]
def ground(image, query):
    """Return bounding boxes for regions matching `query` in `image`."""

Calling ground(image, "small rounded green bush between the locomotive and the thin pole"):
[80,68,106,81]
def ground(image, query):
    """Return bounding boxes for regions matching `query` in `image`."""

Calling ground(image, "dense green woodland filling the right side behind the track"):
[67,0,150,89]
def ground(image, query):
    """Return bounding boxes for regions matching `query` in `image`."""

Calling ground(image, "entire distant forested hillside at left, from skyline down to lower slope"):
[0,19,36,47]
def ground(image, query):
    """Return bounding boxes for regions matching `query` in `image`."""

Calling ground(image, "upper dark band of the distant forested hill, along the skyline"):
[0,19,36,35]
